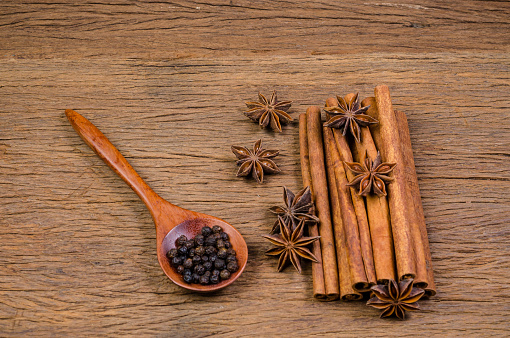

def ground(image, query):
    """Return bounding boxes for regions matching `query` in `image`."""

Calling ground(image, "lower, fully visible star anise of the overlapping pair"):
[263,216,320,273]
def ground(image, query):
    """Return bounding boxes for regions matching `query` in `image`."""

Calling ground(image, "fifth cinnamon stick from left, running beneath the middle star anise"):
[351,99,396,284]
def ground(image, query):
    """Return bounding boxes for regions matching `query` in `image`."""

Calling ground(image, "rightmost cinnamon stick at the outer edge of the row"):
[395,110,436,297]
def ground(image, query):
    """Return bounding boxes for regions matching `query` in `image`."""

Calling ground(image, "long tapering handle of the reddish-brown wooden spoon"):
[66,109,163,214]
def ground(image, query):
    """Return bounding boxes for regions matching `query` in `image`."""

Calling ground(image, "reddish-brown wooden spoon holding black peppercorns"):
[66,109,248,292]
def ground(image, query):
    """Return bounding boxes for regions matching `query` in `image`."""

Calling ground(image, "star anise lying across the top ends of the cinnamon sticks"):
[324,93,379,142]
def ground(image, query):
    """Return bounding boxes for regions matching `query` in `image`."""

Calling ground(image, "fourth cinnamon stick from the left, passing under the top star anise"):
[326,94,377,286]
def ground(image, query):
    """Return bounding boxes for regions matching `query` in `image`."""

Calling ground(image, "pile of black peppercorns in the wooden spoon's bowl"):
[166,225,239,285]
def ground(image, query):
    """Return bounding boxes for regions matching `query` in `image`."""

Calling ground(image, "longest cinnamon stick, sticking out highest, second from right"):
[369,85,416,279]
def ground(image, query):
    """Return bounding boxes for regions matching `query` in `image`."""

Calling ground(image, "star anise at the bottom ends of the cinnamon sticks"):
[367,279,425,320]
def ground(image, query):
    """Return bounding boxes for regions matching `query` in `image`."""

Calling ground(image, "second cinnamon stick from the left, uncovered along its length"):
[306,106,339,299]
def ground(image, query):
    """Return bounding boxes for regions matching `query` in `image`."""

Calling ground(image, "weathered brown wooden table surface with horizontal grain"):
[0,0,510,337]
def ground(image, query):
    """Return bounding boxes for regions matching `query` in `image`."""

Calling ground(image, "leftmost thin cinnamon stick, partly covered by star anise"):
[299,114,328,301]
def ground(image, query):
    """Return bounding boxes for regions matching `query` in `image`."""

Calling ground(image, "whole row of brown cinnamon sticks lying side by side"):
[299,86,436,301]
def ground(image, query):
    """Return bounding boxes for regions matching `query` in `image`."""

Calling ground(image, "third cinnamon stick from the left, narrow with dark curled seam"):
[323,127,363,301]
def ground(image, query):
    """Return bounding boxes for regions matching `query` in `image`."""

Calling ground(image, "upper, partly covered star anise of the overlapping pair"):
[269,187,319,234]
